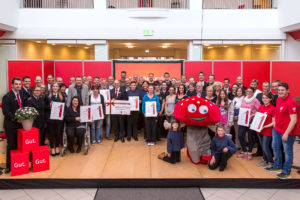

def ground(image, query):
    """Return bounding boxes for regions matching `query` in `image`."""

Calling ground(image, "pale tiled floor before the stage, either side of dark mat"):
[0,188,300,200]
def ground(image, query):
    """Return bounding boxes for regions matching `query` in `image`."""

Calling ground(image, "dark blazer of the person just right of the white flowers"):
[26,96,46,129]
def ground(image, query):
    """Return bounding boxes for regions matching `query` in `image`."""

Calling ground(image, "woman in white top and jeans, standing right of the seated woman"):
[89,85,105,144]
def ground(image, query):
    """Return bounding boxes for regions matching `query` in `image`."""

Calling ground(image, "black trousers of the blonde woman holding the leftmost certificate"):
[48,120,63,149]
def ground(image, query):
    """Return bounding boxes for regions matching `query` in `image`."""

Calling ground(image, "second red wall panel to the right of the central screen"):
[214,61,241,84]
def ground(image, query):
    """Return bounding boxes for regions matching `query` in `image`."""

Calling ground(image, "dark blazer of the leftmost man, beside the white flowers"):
[2,90,24,130]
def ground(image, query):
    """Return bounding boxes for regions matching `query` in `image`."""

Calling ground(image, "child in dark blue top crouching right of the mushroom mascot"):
[208,125,236,171]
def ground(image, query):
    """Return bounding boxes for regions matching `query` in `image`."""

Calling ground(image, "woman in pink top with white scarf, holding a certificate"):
[238,87,260,160]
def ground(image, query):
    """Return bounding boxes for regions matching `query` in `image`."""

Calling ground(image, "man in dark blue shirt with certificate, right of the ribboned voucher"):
[126,81,141,141]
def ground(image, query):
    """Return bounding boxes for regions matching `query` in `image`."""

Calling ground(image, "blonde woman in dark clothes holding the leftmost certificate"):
[45,83,65,156]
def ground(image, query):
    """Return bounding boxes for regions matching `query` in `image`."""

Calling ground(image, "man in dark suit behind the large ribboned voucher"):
[110,80,128,143]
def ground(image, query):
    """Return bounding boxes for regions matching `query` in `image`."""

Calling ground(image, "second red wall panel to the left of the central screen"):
[54,61,83,83]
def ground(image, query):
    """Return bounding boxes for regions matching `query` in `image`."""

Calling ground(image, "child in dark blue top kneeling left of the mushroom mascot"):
[158,119,184,164]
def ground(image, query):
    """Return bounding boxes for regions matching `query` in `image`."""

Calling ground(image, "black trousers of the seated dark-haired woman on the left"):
[66,127,86,149]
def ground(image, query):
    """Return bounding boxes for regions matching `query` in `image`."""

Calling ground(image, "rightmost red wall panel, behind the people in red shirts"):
[272,61,300,97]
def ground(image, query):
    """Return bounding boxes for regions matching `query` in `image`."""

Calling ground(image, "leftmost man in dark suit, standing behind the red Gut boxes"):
[2,77,24,173]
